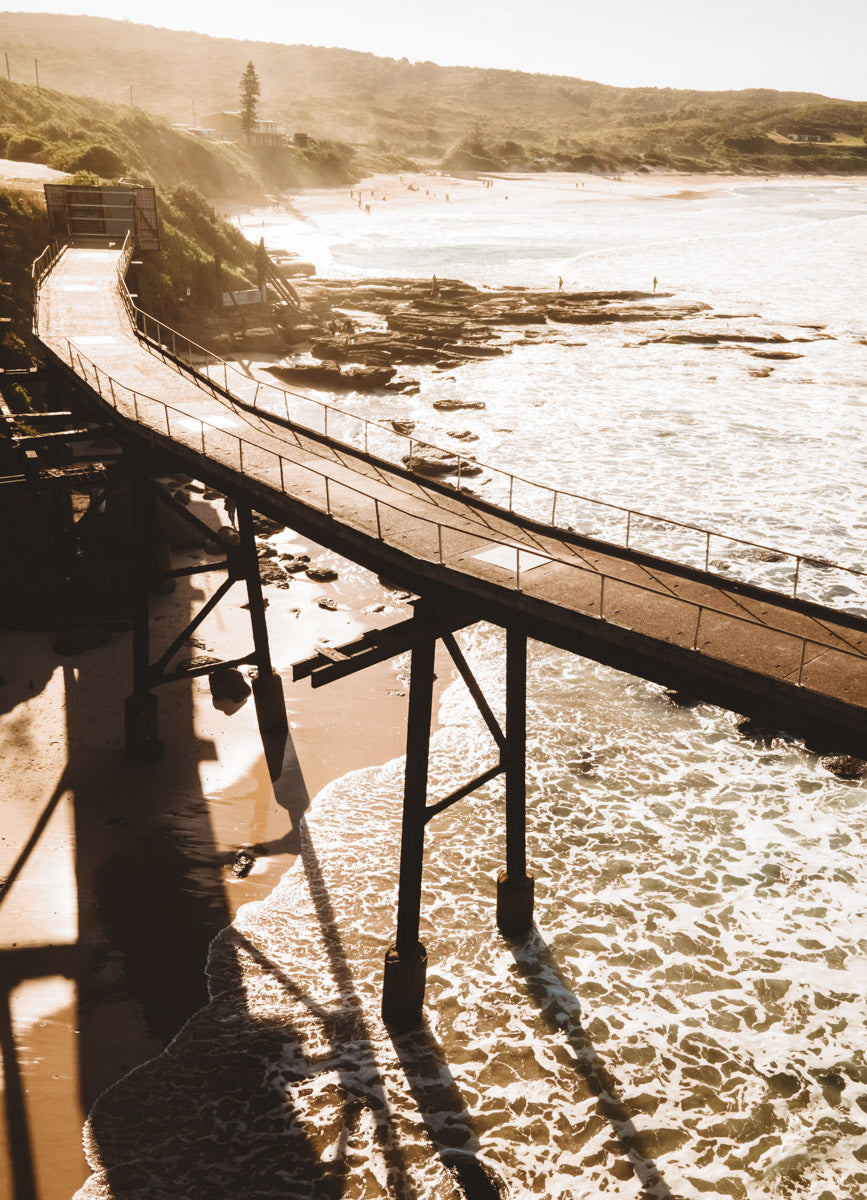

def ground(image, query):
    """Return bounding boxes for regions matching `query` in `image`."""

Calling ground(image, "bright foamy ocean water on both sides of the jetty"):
[79,178,867,1200]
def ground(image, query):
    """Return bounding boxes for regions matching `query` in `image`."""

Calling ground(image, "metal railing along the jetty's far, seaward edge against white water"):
[103,248,867,606]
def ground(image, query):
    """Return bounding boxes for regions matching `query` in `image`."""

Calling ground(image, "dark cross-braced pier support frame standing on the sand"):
[125,469,288,768]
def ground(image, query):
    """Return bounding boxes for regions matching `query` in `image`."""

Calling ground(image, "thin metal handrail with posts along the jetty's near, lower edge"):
[42,328,867,695]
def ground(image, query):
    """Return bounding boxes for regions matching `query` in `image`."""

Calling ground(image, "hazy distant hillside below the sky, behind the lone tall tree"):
[0,13,867,173]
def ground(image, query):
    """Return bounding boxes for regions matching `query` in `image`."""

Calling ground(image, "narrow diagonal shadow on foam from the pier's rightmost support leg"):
[509,928,677,1200]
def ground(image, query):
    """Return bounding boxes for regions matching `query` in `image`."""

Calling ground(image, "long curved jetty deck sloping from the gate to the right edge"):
[38,246,867,756]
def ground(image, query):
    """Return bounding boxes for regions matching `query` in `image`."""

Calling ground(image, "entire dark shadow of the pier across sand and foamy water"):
[0,628,675,1200]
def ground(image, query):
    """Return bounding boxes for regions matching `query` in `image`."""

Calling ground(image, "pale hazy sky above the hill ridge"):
[10,0,867,100]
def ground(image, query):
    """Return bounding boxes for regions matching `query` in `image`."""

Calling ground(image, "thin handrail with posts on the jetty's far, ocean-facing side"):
[108,252,867,599]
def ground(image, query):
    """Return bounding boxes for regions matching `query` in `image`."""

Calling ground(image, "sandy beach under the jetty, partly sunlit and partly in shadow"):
[0,487,446,1200]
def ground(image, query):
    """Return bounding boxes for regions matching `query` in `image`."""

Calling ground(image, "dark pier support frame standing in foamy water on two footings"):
[293,601,534,1031]
